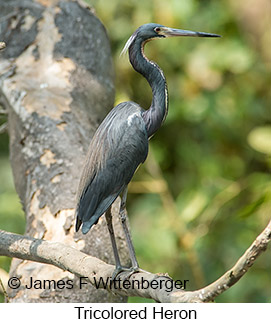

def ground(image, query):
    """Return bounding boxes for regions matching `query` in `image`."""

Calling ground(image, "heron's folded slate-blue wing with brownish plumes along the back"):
[76,102,148,233]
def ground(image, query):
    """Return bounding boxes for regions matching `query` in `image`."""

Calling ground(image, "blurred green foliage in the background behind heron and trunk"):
[0,0,271,302]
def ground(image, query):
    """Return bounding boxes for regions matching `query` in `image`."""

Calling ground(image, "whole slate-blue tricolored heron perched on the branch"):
[76,23,219,276]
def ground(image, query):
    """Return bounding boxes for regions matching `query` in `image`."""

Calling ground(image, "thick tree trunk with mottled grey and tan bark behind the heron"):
[0,0,131,302]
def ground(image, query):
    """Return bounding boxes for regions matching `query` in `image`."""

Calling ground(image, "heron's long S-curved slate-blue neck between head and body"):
[129,41,168,137]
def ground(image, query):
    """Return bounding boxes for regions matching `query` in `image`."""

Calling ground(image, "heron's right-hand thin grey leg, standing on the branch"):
[119,186,139,271]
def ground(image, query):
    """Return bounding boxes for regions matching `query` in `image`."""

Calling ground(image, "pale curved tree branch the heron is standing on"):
[0,221,271,302]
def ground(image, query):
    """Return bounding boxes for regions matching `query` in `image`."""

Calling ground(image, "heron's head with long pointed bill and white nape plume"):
[122,23,220,53]
